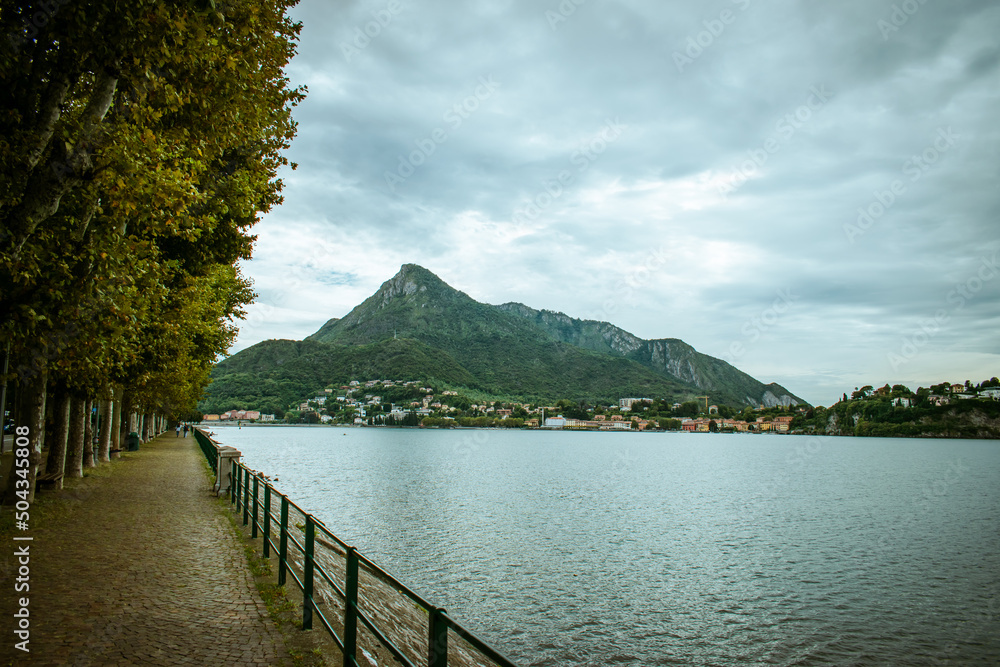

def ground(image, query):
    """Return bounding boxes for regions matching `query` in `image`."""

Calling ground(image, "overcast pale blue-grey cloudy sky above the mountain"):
[234,0,1000,405]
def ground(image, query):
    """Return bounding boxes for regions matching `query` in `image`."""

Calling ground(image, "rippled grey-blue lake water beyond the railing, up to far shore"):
[207,427,1000,667]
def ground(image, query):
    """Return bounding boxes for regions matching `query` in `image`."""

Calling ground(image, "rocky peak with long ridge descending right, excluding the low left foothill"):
[302,264,800,405]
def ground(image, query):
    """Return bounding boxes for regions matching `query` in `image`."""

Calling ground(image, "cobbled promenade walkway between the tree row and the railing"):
[0,431,291,667]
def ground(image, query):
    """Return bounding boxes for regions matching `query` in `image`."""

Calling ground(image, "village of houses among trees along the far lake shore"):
[203,380,1000,433]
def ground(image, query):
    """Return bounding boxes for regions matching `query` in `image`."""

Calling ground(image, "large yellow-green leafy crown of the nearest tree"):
[0,0,302,330]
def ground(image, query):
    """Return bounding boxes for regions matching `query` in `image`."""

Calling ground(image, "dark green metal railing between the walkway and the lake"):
[195,430,516,667]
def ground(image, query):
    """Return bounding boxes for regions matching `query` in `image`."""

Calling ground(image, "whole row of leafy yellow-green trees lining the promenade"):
[0,0,304,502]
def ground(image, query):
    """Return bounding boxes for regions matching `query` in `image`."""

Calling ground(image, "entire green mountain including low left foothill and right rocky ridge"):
[201,264,803,412]
